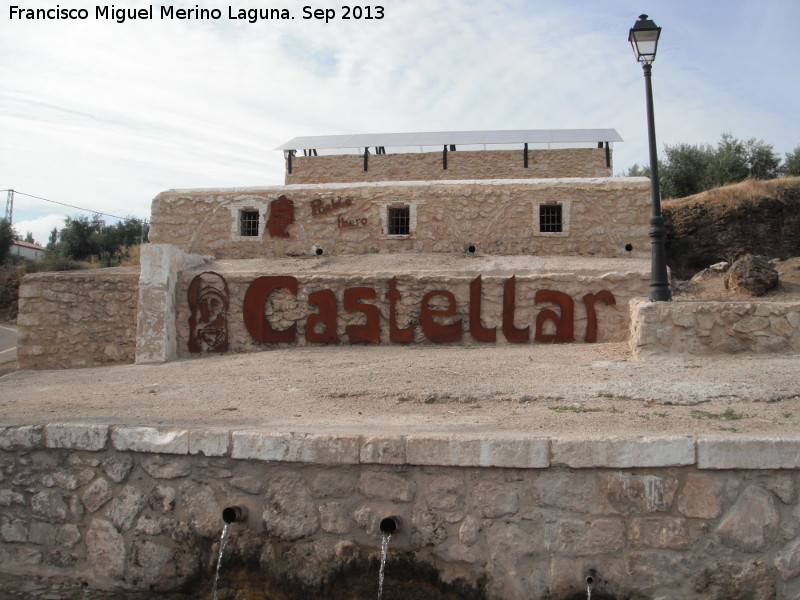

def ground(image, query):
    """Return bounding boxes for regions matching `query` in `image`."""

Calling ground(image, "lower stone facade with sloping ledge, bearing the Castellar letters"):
[175,255,649,356]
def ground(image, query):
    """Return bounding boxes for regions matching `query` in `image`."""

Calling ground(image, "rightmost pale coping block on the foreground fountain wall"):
[697,436,800,469]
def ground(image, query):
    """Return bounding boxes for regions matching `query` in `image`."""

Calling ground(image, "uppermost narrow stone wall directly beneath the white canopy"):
[286,148,613,185]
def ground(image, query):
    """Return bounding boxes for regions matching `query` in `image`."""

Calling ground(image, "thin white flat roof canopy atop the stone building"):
[275,129,623,150]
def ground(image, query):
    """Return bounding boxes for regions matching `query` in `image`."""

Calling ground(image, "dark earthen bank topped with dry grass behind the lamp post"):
[662,177,800,278]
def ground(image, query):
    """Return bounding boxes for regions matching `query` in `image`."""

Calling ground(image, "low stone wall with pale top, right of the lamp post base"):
[630,300,800,356]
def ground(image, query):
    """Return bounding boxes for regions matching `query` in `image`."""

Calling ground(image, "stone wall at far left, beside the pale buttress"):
[17,267,139,369]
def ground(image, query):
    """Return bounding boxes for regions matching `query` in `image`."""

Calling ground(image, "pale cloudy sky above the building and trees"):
[0,0,800,244]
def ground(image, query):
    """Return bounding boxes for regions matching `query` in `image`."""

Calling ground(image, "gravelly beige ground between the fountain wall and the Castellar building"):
[0,344,800,436]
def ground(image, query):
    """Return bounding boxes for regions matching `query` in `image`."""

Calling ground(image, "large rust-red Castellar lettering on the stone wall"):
[243,275,616,344]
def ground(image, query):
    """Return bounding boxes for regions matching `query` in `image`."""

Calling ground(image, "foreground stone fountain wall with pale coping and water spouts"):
[0,424,800,600]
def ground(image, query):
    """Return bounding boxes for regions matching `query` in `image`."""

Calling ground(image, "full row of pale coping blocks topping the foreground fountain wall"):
[0,423,800,470]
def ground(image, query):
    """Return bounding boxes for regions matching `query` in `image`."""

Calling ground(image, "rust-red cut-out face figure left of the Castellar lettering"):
[187,271,230,352]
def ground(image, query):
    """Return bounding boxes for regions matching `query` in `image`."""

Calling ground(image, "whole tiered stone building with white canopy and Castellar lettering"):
[20,129,650,368]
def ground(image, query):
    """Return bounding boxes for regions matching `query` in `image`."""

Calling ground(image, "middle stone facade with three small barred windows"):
[150,177,650,259]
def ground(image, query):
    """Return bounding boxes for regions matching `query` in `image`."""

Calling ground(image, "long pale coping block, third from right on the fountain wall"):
[406,435,550,469]
